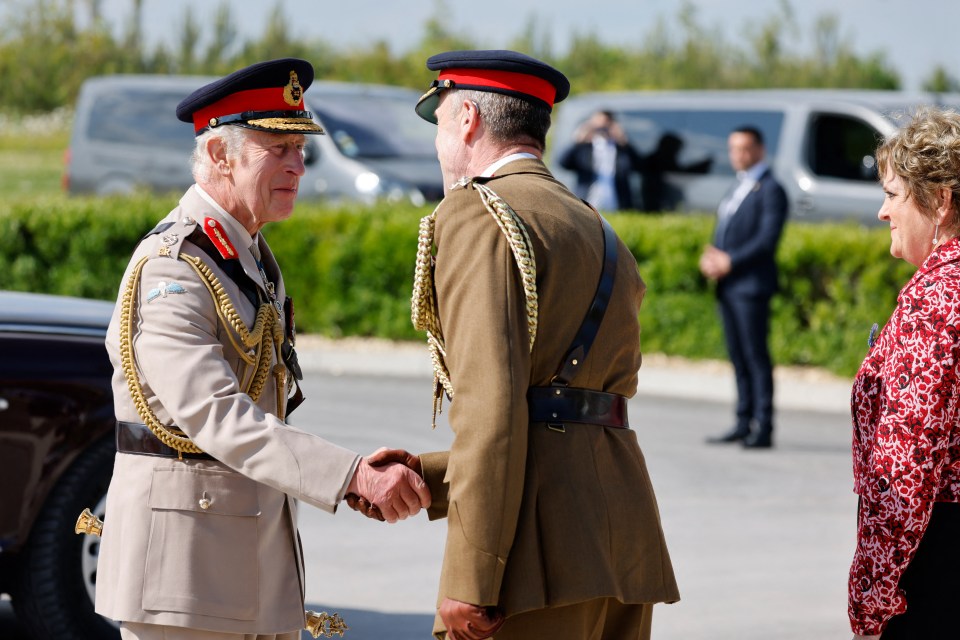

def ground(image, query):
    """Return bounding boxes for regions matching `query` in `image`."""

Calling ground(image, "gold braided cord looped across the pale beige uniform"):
[120,254,287,453]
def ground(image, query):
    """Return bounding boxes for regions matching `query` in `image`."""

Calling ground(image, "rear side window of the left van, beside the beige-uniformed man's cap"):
[87,87,194,153]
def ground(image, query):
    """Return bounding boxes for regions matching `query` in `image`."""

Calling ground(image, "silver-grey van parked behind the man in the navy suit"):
[551,89,960,224]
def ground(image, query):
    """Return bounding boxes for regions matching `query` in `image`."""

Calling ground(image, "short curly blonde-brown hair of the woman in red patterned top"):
[877,107,960,235]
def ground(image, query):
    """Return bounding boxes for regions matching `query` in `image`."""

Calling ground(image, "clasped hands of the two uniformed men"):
[344,448,431,522]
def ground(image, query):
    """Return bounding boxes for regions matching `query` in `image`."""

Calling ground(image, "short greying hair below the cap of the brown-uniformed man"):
[447,89,550,151]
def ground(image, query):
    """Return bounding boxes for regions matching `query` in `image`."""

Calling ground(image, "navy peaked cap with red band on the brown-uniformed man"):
[417,49,570,124]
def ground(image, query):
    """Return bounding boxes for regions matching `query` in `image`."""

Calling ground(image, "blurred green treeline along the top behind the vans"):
[0,0,912,112]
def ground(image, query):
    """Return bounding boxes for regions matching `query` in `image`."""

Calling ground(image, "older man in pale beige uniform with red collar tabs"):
[96,59,430,640]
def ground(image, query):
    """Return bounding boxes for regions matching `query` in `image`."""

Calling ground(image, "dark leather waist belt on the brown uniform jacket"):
[527,387,630,429]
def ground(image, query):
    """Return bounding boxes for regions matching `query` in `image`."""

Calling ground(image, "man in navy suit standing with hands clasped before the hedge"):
[700,127,787,449]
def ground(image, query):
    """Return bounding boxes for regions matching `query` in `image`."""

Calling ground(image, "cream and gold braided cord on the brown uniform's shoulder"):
[410,178,539,428]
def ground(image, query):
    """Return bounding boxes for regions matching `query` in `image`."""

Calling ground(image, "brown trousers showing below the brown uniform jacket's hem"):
[494,598,653,640]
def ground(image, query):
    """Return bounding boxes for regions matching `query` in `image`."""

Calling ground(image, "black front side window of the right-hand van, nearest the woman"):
[807,113,882,182]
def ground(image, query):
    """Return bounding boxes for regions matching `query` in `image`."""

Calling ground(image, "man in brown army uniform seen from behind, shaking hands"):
[356,51,679,640]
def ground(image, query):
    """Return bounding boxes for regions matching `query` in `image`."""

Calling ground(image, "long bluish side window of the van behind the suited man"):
[617,109,783,175]
